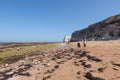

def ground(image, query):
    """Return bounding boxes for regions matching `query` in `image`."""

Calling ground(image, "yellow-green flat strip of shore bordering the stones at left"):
[0,43,57,66]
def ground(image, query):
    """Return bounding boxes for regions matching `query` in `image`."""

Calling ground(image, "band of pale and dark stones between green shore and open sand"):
[0,46,73,80]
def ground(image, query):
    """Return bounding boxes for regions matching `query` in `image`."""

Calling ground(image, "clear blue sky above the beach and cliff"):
[0,0,120,42]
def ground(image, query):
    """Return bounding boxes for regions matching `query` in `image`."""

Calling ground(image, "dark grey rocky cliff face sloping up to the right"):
[71,14,120,41]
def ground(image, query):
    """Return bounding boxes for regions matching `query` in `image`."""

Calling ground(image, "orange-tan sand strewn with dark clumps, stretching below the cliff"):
[8,40,120,80]
